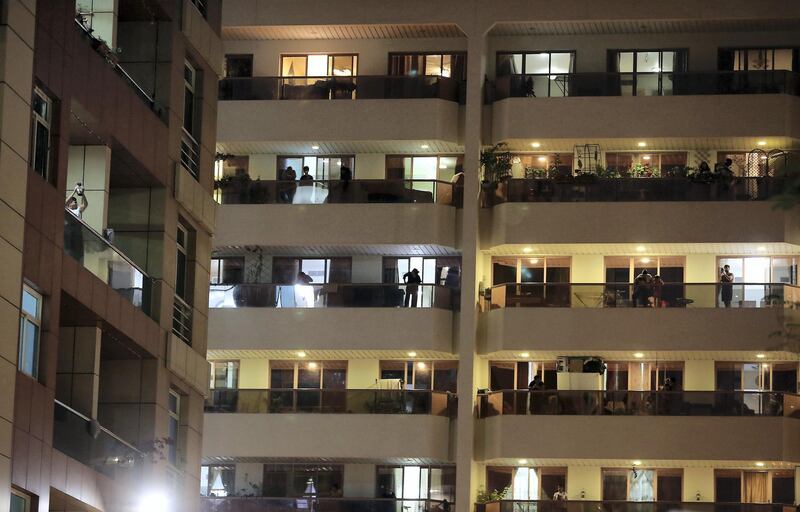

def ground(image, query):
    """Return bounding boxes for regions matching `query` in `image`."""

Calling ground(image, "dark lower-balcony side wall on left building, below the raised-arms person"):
[56,327,103,418]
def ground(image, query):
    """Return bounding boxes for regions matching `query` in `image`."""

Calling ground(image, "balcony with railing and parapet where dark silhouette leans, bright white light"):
[208,284,453,353]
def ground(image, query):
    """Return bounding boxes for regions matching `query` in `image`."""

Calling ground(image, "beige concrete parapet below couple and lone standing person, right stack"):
[481,308,783,353]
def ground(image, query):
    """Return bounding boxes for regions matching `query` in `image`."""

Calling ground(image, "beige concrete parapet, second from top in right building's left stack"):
[213,204,456,247]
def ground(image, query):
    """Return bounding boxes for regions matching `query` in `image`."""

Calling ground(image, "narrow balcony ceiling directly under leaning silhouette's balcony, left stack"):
[206,347,458,361]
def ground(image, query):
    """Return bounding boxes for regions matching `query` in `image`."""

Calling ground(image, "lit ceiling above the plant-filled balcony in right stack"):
[496,136,800,152]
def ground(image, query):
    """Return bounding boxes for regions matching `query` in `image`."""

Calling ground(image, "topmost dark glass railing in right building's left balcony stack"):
[219,76,464,101]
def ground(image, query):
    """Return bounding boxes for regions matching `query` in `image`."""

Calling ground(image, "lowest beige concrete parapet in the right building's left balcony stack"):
[203,414,450,461]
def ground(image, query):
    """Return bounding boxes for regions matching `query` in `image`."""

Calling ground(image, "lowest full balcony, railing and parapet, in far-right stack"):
[476,400,800,462]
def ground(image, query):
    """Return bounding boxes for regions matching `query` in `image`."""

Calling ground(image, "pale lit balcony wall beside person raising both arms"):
[66,146,111,233]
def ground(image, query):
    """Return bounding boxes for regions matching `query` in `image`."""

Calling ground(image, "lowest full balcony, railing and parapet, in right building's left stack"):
[203,400,451,462]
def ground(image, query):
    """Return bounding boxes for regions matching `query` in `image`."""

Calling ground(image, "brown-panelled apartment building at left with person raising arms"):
[0,0,221,512]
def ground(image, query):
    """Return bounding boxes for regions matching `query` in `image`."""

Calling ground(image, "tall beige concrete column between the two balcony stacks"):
[455,26,488,512]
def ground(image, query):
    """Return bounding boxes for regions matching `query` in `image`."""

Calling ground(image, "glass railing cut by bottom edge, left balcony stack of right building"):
[200,496,450,512]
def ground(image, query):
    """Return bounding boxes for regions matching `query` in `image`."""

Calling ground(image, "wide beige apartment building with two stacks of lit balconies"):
[205,0,800,512]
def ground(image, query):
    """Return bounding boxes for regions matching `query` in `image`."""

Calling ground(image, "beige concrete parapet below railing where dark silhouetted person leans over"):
[208,308,453,354]
